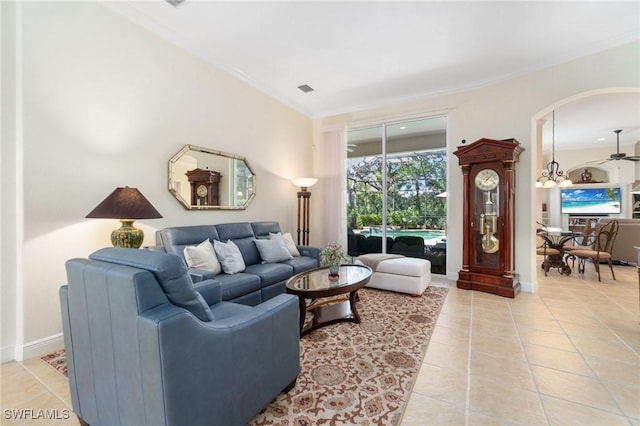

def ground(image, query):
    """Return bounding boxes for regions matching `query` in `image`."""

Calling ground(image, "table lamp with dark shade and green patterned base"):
[86,186,162,248]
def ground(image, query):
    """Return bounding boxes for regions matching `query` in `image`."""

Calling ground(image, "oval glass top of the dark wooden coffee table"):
[287,265,371,291]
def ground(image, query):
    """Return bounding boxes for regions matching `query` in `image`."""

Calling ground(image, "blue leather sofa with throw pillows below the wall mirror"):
[156,222,320,306]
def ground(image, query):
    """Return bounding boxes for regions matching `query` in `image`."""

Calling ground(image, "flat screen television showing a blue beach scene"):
[560,187,621,215]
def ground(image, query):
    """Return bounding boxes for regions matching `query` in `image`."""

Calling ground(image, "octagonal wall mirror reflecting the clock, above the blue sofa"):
[169,145,256,210]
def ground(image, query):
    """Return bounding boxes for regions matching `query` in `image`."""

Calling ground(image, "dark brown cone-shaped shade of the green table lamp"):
[86,186,162,219]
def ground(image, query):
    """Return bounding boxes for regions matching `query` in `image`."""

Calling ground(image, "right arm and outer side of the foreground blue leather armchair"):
[138,297,300,425]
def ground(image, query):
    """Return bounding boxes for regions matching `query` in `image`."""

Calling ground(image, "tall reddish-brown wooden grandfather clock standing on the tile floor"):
[454,138,524,297]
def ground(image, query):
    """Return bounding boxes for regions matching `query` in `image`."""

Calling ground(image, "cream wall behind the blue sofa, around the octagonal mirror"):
[2,2,313,361]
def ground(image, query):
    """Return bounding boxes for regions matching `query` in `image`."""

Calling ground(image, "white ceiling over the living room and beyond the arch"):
[103,0,640,148]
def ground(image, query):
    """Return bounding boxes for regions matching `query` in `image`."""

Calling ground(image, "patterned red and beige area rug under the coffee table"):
[41,287,448,426]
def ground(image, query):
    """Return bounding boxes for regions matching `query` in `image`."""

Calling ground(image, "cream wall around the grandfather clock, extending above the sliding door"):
[323,42,640,291]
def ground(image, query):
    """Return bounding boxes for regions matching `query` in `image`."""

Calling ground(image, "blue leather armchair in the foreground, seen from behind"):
[60,248,300,426]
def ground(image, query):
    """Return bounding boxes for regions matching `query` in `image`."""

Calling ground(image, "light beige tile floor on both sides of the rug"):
[0,265,640,426]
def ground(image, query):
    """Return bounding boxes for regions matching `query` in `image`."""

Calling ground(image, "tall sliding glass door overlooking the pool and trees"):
[346,117,447,257]
